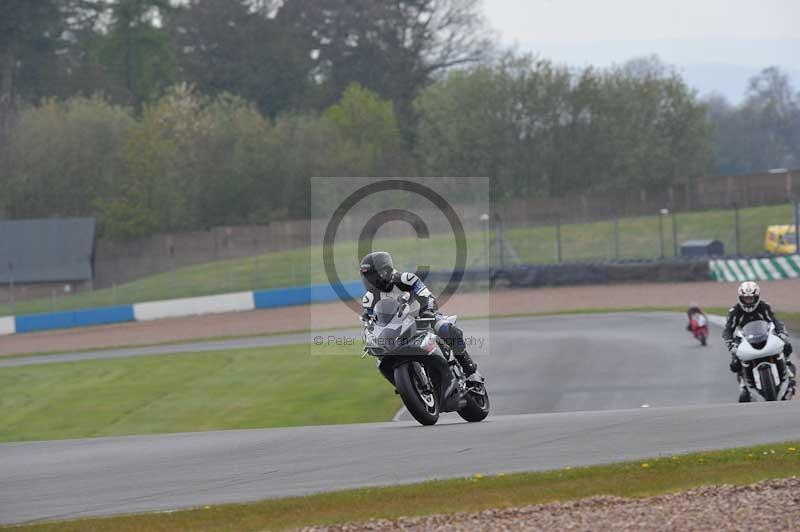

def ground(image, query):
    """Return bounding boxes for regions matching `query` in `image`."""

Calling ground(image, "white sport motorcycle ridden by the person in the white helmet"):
[736,321,794,401]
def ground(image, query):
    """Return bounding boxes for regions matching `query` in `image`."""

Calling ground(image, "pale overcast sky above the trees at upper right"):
[484,0,800,100]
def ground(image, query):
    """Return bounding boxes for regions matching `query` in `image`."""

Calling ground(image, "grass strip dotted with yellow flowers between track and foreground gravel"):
[7,442,800,532]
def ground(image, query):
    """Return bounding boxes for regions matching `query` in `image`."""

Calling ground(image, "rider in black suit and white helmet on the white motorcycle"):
[722,281,797,403]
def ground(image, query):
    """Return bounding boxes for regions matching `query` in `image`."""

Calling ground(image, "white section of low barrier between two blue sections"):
[133,292,256,321]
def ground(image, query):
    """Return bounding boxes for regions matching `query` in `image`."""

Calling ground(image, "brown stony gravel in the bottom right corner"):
[303,478,800,532]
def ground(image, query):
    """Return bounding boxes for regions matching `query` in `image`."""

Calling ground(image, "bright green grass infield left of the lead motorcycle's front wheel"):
[0,345,390,442]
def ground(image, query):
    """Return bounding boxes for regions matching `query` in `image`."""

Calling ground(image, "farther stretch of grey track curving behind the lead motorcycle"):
[0,312,737,414]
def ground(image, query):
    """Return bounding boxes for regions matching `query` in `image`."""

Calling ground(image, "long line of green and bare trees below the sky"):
[0,0,800,238]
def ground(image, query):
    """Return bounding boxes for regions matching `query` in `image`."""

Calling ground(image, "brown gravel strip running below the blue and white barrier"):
[0,279,800,355]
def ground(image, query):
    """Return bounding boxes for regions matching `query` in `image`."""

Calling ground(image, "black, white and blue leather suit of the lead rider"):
[361,271,477,375]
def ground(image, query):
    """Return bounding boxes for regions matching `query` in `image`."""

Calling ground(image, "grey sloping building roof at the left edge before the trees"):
[0,218,95,283]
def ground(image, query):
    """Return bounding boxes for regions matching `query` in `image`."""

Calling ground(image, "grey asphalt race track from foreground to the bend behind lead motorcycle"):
[0,313,800,523]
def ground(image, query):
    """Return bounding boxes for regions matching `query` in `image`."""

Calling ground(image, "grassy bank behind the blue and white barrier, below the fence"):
[0,205,792,316]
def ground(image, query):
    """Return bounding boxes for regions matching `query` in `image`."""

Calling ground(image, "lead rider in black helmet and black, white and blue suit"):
[361,251,478,376]
